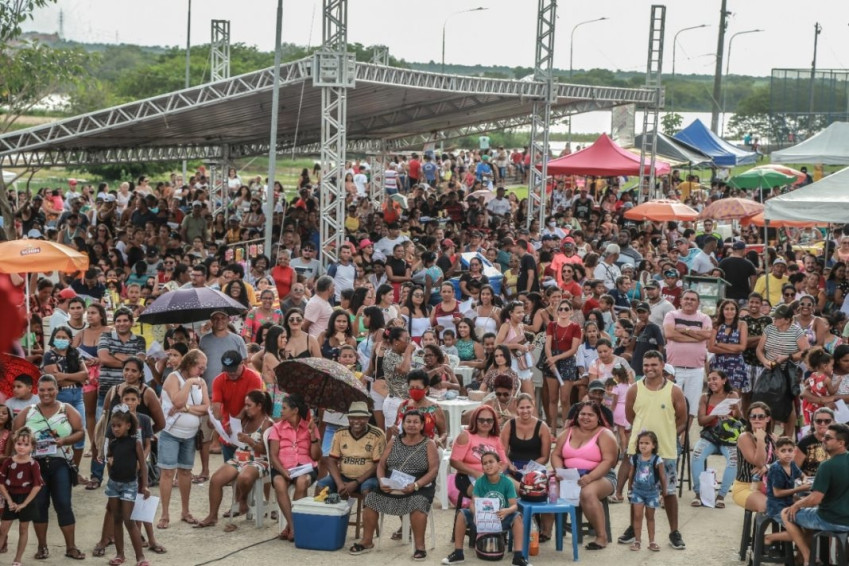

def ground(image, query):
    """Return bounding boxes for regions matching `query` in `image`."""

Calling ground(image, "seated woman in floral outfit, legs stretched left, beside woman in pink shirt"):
[195,390,274,532]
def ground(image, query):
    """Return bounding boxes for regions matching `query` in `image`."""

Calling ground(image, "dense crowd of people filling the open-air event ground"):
[0,153,849,566]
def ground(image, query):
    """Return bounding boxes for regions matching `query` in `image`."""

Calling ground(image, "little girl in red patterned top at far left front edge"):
[0,427,44,566]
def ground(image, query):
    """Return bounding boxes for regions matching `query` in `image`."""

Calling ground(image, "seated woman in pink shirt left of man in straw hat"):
[268,395,321,541]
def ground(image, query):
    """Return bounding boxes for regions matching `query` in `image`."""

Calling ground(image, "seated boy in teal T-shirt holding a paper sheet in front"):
[442,452,531,566]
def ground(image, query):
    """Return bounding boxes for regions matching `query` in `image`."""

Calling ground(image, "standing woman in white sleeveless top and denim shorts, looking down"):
[156,350,209,529]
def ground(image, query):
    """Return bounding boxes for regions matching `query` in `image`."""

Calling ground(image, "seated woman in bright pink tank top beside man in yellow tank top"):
[551,401,618,550]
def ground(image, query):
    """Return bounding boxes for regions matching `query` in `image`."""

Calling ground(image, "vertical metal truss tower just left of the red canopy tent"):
[527,0,557,228]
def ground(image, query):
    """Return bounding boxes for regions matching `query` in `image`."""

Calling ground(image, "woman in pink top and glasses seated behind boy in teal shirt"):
[451,405,509,497]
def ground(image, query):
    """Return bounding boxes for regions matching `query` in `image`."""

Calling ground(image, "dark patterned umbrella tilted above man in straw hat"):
[274,358,372,413]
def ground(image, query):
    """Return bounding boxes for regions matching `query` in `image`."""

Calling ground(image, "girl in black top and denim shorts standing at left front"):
[106,404,150,566]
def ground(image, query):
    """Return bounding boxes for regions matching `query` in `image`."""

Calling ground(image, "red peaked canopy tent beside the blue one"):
[548,134,670,177]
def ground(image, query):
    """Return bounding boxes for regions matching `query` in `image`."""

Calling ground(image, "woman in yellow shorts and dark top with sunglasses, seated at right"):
[731,401,775,513]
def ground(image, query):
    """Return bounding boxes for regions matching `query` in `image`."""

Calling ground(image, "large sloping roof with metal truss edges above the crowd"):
[0,58,656,167]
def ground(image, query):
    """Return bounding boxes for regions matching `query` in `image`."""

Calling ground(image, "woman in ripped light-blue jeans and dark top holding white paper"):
[690,369,740,509]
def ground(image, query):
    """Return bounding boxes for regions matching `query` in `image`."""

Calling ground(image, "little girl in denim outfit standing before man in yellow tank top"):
[628,430,666,552]
